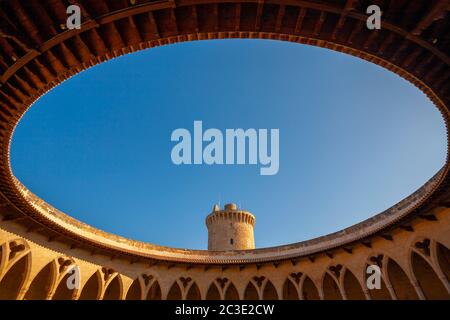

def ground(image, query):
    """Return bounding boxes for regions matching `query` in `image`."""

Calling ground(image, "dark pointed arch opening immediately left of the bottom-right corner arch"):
[387,258,419,300]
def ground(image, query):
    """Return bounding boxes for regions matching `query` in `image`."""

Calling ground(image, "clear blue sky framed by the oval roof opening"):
[11,40,446,249]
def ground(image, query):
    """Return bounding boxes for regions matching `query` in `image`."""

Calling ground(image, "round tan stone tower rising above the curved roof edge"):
[206,203,256,251]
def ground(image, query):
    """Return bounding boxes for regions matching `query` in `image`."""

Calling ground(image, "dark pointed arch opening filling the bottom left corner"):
[0,254,31,300]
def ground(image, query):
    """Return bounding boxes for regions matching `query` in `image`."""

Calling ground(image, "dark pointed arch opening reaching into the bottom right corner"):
[411,251,450,300]
